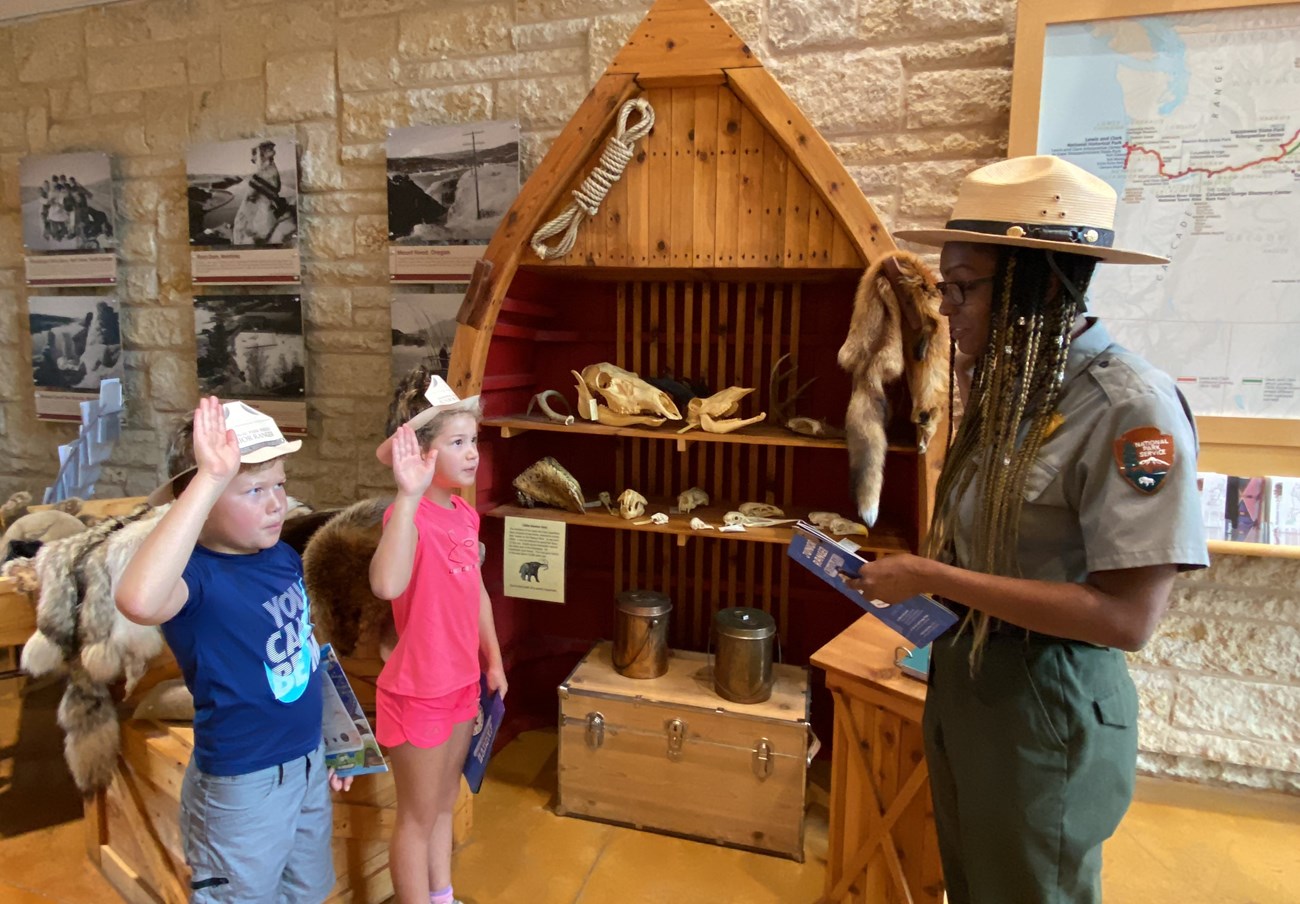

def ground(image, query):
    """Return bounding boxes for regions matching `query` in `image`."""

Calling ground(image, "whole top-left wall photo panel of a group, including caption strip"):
[18,151,118,286]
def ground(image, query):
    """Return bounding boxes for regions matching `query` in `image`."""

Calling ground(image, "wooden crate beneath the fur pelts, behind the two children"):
[86,665,472,904]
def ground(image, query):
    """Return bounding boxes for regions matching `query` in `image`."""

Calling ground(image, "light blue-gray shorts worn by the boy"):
[181,747,334,904]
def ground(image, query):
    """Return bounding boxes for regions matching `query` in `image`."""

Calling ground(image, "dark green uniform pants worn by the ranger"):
[924,630,1138,904]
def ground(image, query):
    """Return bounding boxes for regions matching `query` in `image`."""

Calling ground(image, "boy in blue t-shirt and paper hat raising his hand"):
[116,397,351,904]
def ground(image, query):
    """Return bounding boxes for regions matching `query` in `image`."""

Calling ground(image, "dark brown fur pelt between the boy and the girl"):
[303,498,393,656]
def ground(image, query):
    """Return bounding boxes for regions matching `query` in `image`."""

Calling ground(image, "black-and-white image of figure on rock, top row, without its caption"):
[186,138,298,247]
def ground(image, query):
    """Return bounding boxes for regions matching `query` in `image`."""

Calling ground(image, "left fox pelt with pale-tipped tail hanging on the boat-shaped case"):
[839,258,902,527]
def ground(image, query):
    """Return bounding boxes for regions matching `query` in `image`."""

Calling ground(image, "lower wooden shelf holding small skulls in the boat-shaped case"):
[484,499,911,555]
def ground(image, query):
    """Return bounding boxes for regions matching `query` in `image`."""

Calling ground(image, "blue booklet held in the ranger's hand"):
[787,522,957,646]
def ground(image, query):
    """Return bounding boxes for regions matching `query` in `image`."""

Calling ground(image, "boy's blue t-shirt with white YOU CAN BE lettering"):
[163,542,321,775]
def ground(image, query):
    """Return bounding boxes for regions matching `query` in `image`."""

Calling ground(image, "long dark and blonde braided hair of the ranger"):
[926,248,1097,670]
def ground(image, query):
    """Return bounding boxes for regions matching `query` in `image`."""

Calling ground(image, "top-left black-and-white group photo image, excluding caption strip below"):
[18,151,117,254]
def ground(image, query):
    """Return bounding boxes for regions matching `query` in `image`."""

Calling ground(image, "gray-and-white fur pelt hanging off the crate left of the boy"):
[22,506,164,793]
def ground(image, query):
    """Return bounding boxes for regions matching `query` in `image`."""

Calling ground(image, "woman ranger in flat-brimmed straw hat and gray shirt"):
[849,157,1208,904]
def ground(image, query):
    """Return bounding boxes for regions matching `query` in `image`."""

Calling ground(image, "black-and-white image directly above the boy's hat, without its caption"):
[194,295,307,399]
